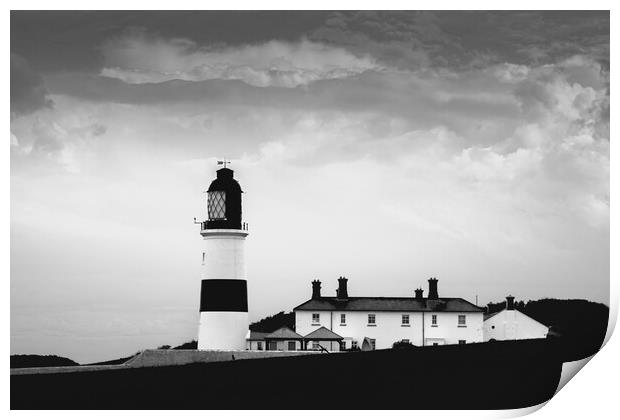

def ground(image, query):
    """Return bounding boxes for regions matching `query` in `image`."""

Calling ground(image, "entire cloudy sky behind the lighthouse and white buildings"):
[10,11,610,363]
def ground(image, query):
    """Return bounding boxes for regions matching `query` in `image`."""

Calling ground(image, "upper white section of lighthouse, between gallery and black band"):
[201,229,248,280]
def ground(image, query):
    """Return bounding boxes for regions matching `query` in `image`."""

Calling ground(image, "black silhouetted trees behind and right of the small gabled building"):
[487,299,609,360]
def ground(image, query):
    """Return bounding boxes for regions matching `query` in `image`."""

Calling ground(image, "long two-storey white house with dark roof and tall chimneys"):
[294,277,484,350]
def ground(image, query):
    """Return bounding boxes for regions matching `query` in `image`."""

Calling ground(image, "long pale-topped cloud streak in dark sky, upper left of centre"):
[101,30,378,87]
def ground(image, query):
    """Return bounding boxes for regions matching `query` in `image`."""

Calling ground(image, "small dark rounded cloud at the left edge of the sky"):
[11,53,53,115]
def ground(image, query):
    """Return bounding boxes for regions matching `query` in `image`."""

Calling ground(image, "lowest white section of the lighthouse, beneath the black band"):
[198,311,248,350]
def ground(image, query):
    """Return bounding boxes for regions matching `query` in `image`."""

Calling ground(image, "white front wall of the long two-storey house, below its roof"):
[295,311,484,349]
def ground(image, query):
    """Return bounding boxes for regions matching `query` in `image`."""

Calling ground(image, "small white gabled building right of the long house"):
[484,296,549,341]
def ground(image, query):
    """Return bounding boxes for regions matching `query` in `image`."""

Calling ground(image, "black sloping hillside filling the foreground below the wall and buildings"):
[11,340,561,409]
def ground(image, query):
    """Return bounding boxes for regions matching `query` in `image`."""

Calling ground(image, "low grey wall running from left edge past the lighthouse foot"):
[11,350,320,375]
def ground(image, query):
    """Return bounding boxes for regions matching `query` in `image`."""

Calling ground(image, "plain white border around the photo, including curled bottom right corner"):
[0,0,620,419]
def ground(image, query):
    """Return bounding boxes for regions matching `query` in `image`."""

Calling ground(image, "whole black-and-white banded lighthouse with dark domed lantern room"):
[198,166,248,350]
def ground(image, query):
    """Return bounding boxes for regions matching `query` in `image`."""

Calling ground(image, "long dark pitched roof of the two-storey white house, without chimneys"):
[293,297,484,312]
